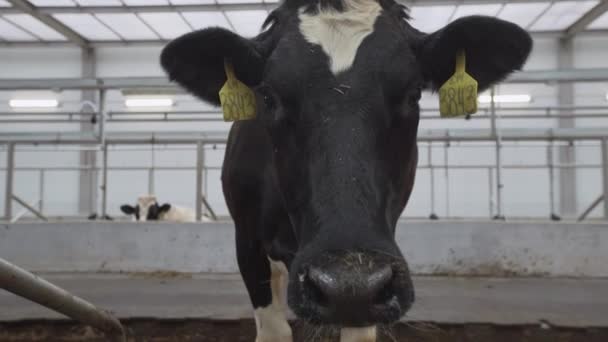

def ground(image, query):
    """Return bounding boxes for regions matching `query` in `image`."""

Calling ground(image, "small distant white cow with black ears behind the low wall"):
[120,195,196,222]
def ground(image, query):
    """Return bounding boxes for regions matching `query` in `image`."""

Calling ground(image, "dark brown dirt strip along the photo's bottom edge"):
[0,320,608,342]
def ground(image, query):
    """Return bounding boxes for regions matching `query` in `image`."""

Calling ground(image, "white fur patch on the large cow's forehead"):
[299,0,382,74]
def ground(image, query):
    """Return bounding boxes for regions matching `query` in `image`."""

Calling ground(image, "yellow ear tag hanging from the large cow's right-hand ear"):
[439,50,477,118]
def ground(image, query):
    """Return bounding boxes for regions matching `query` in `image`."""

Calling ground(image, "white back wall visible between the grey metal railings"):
[0,37,608,217]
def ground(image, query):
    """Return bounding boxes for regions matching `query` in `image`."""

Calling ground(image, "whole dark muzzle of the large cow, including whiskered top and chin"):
[289,253,414,327]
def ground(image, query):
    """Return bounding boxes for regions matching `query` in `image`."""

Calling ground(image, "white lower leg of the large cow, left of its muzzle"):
[254,258,293,342]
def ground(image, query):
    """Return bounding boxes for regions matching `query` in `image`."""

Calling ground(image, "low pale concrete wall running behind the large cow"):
[0,221,608,278]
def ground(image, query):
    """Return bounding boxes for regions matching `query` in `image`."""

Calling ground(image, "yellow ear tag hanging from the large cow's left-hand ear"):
[220,61,255,121]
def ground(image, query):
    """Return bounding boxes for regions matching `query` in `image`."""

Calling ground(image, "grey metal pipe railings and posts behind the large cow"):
[0,74,608,220]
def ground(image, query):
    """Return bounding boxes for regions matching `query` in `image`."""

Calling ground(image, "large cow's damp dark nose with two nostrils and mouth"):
[299,265,413,327]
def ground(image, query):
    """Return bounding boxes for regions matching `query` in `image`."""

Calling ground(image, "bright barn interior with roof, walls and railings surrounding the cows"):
[0,0,608,342]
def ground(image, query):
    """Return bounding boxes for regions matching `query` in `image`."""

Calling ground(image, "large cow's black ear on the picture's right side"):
[418,16,532,91]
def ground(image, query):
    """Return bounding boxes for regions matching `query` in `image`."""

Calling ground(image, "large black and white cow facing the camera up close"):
[161,0,532,342]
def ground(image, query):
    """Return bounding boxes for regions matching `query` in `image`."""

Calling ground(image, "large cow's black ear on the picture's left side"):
[160,28,265,105]
